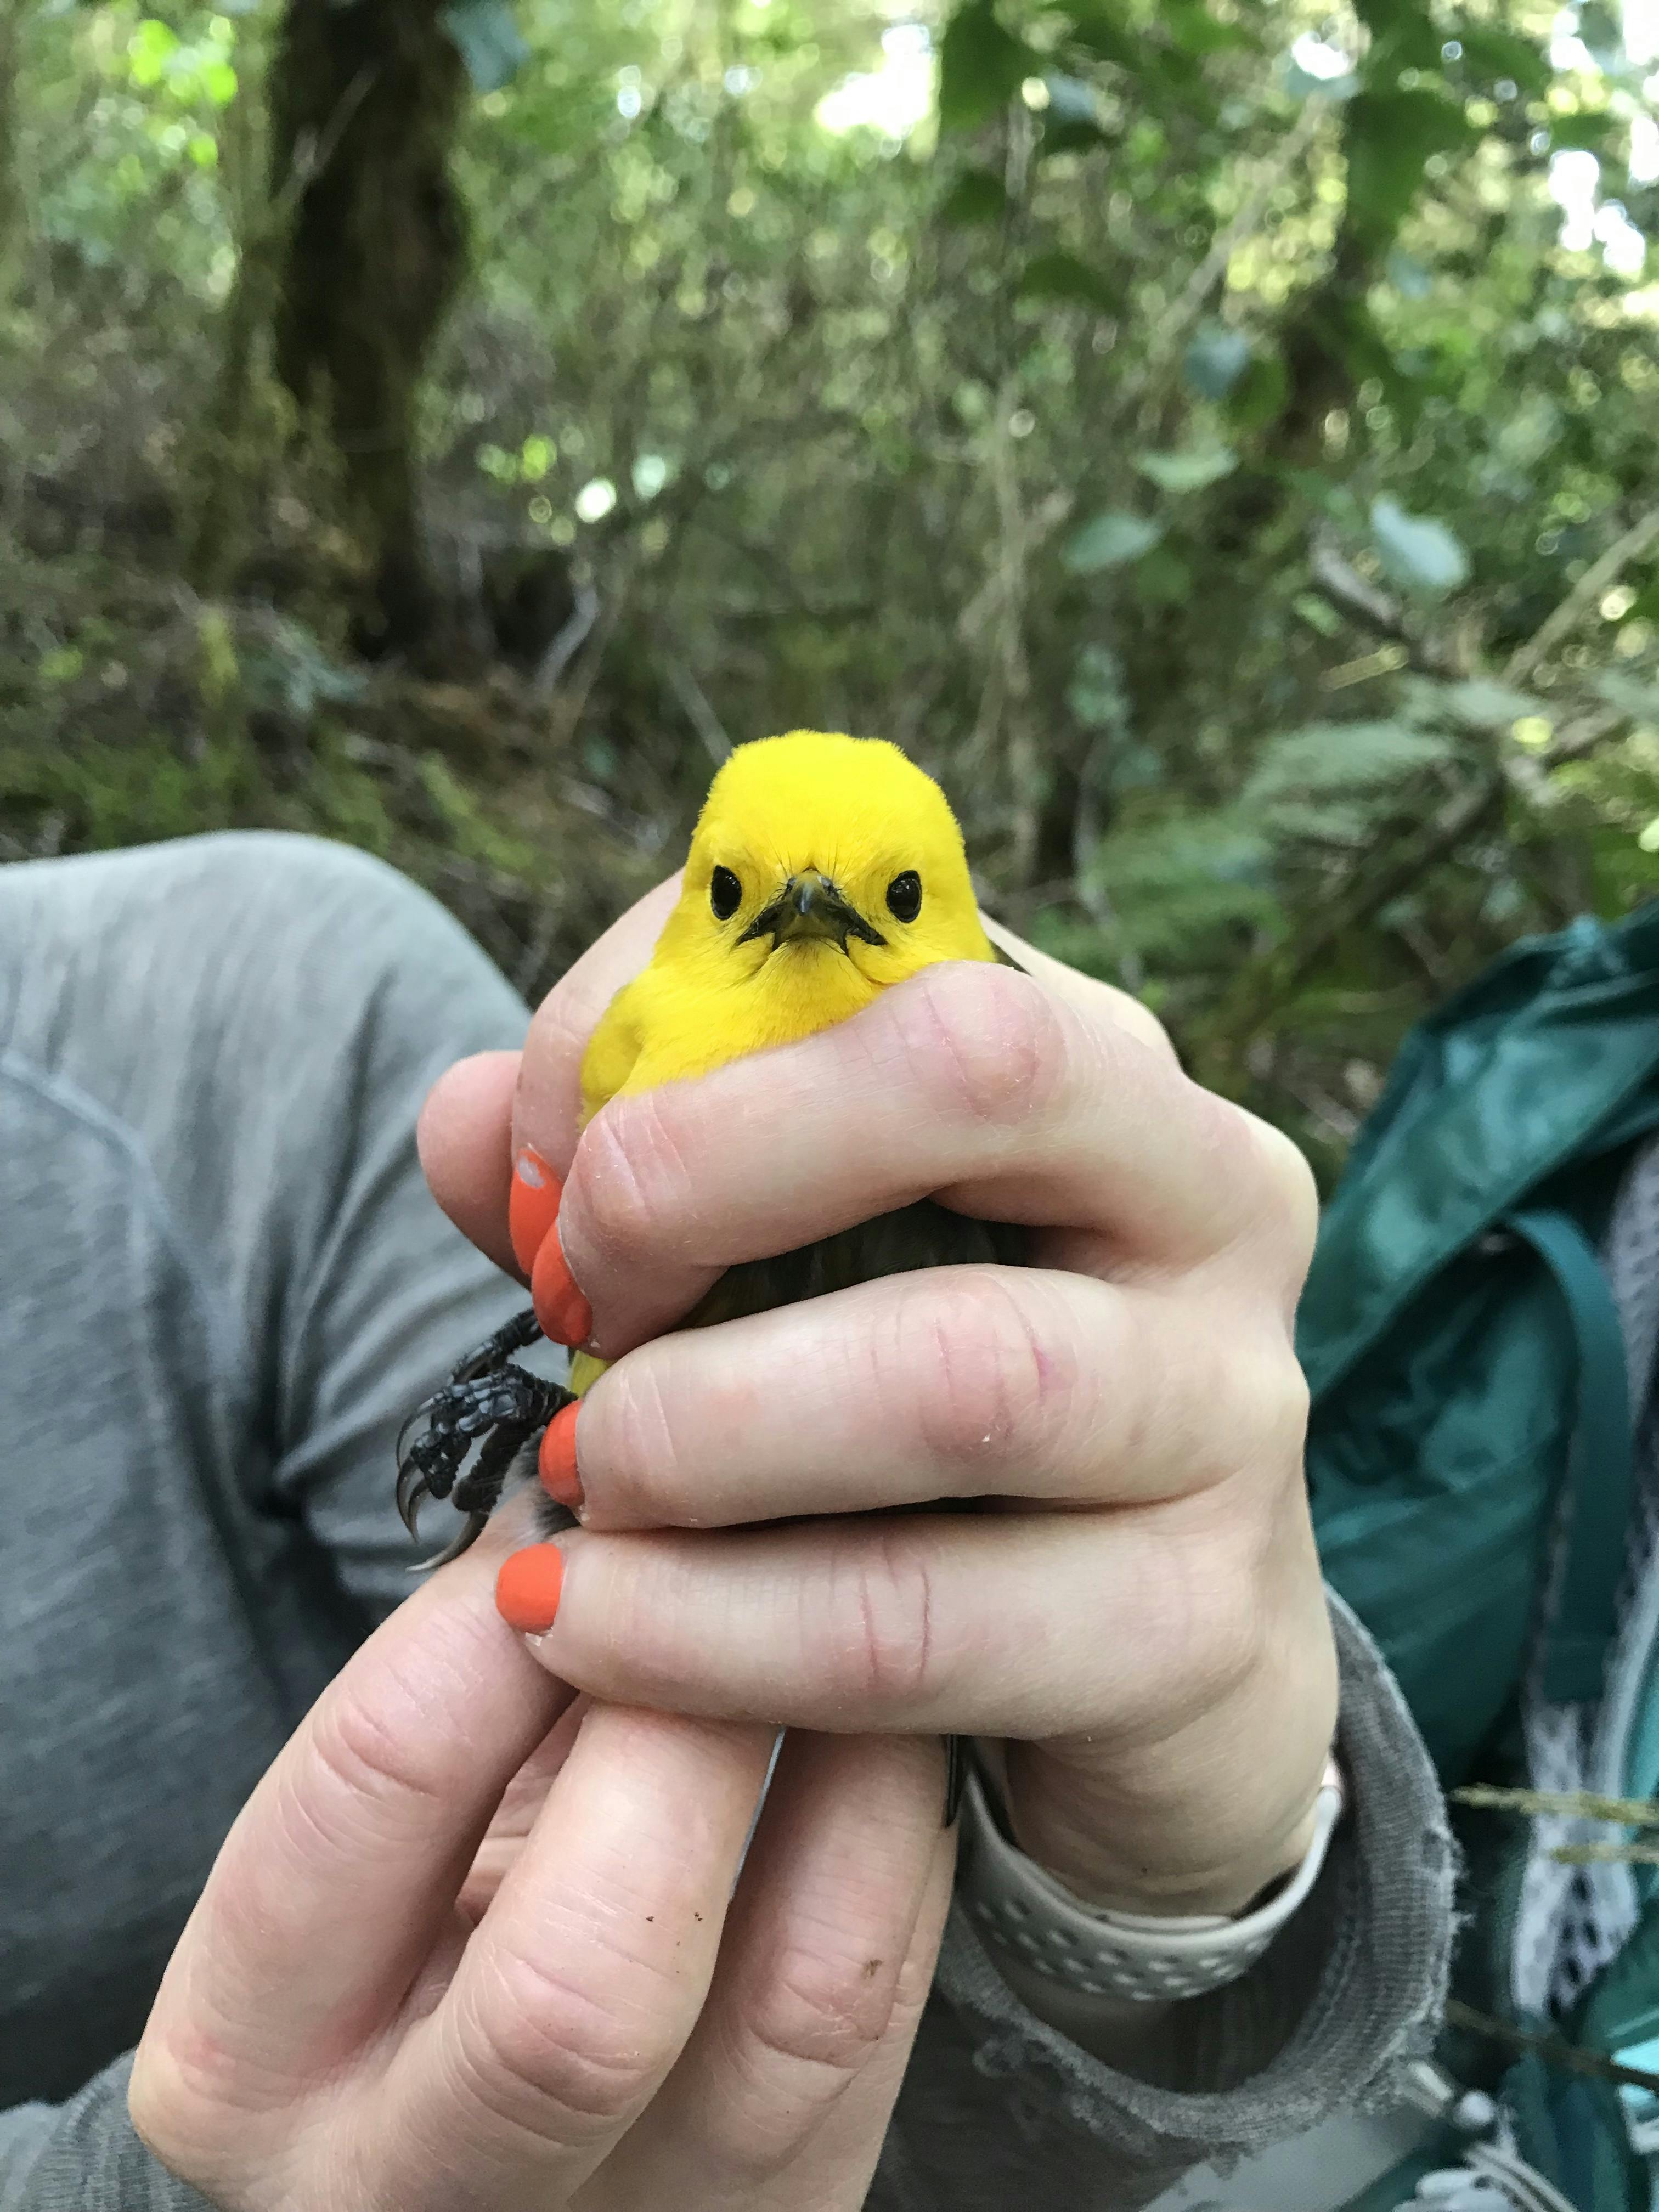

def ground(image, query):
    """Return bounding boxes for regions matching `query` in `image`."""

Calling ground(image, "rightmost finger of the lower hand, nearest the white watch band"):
[604,1734,951,2212]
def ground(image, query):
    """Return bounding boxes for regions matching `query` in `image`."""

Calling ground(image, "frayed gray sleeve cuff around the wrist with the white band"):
[872,1597,1453,2212]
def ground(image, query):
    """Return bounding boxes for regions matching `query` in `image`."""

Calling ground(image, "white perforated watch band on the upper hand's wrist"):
[960,1758,1345,2002]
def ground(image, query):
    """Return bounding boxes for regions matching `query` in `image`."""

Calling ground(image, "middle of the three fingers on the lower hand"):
[371,1706,774,2212]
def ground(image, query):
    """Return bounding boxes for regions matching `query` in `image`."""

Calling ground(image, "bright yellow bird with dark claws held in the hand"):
[398,730,1024,1803]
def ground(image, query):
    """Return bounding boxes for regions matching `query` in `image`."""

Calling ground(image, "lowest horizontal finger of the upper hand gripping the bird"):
[513,1471,1305,1745]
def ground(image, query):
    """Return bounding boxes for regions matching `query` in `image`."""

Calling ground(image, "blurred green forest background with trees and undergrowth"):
[0,0,1659,1177]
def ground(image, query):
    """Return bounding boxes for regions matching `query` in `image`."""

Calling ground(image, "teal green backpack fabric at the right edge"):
[1299,902,1659,1785]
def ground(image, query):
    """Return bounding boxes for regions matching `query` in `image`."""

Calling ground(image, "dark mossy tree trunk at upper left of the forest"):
[270,0,467,654]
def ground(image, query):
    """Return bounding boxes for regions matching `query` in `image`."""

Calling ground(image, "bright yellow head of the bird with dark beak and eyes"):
[662,730,993,1026]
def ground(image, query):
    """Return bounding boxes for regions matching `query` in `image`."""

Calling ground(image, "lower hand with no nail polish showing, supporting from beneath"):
[131,1506,951,2212]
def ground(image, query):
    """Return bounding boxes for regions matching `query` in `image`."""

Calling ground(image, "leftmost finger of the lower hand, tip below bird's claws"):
[135,1546,571,2099]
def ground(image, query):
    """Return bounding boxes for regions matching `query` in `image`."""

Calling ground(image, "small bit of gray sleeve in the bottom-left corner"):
[0,2055,212,2212]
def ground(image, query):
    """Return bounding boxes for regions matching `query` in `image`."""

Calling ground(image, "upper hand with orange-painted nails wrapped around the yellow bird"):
[422,885,1336,1914]
